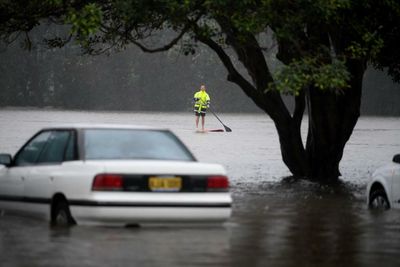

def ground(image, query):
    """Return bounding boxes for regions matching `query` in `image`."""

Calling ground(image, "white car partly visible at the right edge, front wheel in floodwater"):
[367,154,400,210]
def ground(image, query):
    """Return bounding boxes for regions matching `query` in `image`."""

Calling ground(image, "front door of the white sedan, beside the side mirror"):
[0,131,50,214]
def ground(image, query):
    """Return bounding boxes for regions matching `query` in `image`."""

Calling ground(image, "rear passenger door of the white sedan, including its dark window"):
[24,130,74,219]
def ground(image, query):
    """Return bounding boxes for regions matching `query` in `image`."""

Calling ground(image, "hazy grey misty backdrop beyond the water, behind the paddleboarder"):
[0,27,400,116]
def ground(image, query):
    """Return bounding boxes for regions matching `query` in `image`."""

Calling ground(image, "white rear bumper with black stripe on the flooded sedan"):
[70,193,232,225]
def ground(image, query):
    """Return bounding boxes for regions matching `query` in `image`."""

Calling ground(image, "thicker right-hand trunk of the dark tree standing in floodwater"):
[306,61,366,183]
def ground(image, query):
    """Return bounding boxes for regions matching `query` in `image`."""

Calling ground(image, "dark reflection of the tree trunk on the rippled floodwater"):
[282,184,360,266]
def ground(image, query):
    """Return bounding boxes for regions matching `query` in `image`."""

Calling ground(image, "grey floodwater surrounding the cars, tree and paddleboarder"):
[0,109,400,267]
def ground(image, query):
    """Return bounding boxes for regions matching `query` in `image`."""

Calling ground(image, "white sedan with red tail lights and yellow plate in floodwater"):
[0,124,232,225]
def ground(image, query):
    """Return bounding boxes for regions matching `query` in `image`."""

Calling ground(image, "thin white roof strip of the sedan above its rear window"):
[43,123,169,130]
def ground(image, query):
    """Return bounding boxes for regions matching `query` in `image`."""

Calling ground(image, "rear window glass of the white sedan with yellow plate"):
[83,129,194,161]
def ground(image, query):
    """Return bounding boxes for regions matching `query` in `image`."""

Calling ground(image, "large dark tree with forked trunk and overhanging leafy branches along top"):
[0,0,400,181]
